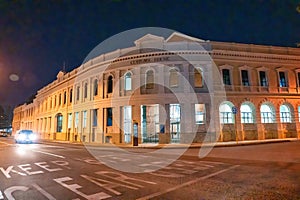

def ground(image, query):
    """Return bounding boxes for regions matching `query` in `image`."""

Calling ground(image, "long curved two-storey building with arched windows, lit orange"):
[13,33,300,144]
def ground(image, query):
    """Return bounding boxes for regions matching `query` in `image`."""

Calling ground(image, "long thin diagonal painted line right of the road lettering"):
[136,165,240,200]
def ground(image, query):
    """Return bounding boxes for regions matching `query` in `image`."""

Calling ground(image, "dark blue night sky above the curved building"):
[0,0,300,106]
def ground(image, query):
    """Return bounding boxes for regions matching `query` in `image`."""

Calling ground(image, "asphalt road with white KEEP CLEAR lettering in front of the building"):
[0,137,300,200]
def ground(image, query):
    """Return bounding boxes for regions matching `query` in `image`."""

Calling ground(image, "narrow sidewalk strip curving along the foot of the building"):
[41,138,300,149]
